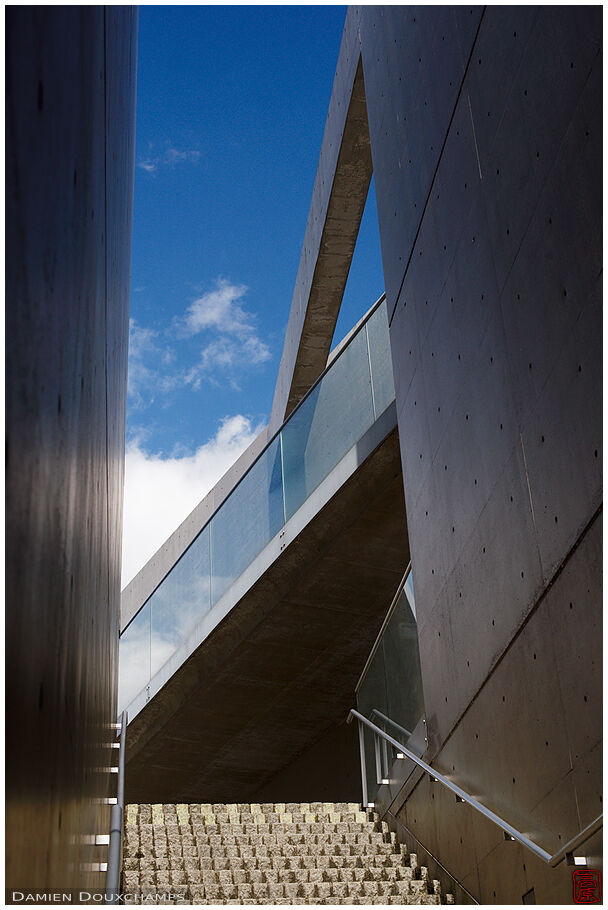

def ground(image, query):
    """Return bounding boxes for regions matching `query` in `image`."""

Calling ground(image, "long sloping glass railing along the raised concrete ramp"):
[119,298,395,710]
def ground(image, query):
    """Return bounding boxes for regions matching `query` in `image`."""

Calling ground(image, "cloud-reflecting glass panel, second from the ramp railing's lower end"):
[150,525,211,676]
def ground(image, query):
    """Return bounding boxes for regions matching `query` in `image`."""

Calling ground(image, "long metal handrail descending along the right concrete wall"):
[347,708,603,866]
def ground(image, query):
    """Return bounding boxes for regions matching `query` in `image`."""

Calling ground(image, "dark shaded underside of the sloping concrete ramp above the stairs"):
[126,430,408,803]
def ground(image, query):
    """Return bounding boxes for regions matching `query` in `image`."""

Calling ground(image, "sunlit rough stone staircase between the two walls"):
[122,803,453,904]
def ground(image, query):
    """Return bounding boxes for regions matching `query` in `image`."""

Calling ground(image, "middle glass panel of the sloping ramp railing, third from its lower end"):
[211,437,285,603]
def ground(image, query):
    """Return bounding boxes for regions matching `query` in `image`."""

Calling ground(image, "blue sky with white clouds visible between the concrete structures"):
[123,6,383,583]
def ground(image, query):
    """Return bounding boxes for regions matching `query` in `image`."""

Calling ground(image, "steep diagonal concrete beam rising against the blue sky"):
[269,9,372,433]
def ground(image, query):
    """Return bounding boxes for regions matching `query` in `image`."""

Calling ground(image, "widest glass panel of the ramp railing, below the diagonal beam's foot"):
[281,330,374,519]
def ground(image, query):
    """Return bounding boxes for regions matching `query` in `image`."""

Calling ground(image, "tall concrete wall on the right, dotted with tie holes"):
[349,7,602,903]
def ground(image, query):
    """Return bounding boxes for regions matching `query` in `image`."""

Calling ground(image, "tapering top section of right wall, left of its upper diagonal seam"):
[354,6,483,317]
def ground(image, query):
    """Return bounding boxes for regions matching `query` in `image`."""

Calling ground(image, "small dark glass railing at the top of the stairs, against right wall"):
[357,568,424,802]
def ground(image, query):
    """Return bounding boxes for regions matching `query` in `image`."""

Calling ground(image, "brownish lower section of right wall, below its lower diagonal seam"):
[393,518,602,903]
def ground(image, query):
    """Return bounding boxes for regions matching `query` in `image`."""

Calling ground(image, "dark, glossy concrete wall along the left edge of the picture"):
[6,7,136,890]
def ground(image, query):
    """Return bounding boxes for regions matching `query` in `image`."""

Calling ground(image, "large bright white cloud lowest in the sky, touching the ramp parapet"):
[122,414,261,587]
